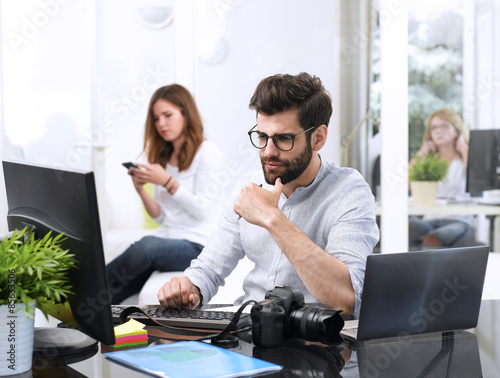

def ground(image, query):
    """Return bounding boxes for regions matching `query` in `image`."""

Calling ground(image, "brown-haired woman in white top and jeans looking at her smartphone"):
[107,84,224,304]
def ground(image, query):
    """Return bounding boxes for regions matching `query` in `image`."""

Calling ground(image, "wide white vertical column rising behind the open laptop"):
[380,0,408,253]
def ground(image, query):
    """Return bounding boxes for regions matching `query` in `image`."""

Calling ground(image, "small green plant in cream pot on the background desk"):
[408,153,450,207]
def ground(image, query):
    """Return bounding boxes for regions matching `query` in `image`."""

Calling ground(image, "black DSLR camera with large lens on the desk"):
[250,286,344,347]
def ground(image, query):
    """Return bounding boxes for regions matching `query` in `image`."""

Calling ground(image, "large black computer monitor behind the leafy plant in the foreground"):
[3,161,115,345]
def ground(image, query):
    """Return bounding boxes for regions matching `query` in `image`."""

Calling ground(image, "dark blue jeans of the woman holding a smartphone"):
[106,236,203,304]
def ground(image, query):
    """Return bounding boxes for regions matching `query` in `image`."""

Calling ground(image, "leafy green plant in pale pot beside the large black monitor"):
[0,228,76,376]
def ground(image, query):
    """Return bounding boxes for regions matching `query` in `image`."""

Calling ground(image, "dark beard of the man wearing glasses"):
[260,142,312,185]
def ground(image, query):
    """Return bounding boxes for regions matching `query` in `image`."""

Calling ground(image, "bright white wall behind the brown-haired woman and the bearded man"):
[0,0,340,233]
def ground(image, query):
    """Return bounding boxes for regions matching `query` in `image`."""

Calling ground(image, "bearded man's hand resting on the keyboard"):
[158,276,201,310]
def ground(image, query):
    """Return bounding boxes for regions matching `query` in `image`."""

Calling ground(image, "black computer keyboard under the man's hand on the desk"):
[111,305,251,330]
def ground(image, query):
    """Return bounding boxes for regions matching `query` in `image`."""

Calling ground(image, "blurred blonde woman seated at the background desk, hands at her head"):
[409,109,474,247]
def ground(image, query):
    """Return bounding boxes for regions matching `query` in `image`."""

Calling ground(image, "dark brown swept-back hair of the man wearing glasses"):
[249,72,332,130]
